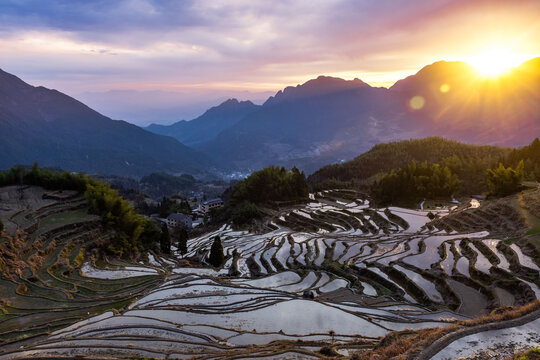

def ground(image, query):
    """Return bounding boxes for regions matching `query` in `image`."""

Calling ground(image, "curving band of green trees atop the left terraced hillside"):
[0,164,160,257]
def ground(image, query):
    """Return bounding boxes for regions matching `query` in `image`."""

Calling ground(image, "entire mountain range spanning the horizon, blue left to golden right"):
[0,58,540,176]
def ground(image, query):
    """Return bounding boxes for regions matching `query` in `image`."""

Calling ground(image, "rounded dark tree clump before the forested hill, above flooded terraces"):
[371,160,462,205]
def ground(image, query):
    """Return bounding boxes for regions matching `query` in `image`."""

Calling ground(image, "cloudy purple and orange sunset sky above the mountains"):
[0,0,540,125]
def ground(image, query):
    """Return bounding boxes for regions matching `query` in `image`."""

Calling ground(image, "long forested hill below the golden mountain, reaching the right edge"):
[308,137,540,203]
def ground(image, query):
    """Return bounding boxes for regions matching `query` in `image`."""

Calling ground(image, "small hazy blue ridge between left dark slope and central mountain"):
[146,99,260,146]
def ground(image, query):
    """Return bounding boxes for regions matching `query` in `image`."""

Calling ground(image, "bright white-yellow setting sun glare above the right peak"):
[467,48,526,77]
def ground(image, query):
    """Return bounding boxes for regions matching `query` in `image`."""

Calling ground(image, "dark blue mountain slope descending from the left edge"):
[0,70,213,175]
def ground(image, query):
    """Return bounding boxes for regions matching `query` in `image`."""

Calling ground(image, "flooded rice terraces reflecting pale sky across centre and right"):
[0,187,540,359]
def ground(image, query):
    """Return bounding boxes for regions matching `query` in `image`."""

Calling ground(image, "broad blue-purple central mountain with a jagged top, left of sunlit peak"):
[196,76,412,172]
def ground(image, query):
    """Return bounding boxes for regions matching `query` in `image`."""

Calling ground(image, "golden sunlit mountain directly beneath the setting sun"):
[390,58,540,146]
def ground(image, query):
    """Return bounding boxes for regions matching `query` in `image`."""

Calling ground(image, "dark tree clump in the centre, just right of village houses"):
[222,166,309,225]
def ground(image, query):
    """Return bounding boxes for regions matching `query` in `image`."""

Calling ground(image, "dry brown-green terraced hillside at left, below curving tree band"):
[0,187,163,348]
